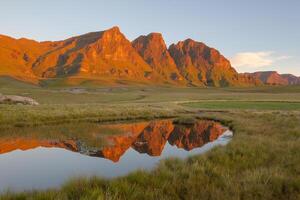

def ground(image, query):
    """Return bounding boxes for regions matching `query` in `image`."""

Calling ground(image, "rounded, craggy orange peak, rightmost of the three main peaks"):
[169,39,238,86]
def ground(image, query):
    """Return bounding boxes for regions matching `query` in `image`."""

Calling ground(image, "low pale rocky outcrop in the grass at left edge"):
[0,93,39,106]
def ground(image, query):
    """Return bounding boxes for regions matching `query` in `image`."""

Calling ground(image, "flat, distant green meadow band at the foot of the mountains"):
[0,78,300,105]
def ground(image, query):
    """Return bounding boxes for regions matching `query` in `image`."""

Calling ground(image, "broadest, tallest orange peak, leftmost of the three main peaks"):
[33,27,155,81]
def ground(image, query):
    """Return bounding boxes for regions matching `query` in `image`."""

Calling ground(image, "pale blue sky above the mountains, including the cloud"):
[0,0,300,76]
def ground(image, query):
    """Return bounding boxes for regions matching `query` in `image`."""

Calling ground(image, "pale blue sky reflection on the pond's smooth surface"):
[0,131,230,191]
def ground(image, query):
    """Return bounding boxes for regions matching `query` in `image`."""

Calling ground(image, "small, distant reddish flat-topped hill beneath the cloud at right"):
[243,71,300,85]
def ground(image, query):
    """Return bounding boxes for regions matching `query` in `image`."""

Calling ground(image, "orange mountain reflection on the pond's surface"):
[0,120,226,162]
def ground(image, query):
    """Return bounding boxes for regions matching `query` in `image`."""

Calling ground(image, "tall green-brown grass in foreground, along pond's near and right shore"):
[1,111,300,200]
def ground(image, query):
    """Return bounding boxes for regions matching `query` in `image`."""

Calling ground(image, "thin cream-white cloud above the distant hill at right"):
[230,51,290,68]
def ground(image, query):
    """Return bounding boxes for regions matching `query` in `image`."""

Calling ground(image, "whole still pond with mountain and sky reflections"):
[0,119,232,192]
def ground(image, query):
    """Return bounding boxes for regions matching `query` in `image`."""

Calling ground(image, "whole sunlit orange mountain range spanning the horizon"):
[0,27,299,87]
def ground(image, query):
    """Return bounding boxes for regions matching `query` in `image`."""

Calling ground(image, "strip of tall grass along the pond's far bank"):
[0,103,185,130]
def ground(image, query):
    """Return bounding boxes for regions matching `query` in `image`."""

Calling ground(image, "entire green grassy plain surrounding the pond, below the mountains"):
[0,79,300,200]
